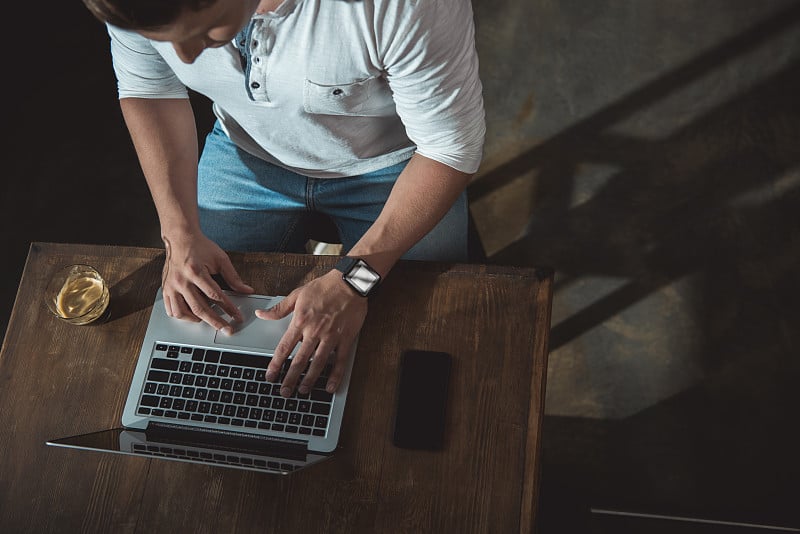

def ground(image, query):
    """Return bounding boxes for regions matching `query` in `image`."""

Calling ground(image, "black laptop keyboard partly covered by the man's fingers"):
[136,343,334,436]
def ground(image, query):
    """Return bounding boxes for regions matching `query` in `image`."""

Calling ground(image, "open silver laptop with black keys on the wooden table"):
[47,288,358,475]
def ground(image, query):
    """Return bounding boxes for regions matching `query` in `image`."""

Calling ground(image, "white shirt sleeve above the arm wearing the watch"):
[376,0,486,173]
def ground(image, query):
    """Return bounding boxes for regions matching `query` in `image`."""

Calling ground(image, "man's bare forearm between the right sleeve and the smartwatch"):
[347,154,472,277]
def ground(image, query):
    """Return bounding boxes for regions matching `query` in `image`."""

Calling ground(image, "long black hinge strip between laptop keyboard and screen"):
[145,422,308,460]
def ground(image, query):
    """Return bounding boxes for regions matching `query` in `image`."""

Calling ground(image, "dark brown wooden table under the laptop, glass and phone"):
[0,243,552,534]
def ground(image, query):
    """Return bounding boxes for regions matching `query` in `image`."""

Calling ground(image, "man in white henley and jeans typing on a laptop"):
[83,0,485,396]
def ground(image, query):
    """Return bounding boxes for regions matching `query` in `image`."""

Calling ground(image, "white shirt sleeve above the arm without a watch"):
[106,24,189,98]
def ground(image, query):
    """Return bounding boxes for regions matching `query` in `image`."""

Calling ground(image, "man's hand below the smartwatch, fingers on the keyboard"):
[256,271,367,397]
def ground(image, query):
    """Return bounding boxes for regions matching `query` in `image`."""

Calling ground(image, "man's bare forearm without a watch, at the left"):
[120,98,205,243]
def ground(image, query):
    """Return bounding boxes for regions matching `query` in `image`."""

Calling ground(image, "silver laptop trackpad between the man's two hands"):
[214,295,292,352]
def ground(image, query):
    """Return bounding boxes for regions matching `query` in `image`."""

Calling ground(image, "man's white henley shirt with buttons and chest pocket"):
[108,0,485,178]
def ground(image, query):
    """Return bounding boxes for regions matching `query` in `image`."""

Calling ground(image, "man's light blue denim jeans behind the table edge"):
[198,125,468,262]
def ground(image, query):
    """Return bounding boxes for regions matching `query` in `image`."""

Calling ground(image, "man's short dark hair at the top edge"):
[83,0,217,30]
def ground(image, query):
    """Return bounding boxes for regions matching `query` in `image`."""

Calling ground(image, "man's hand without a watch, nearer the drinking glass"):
[161,234,253,335]
